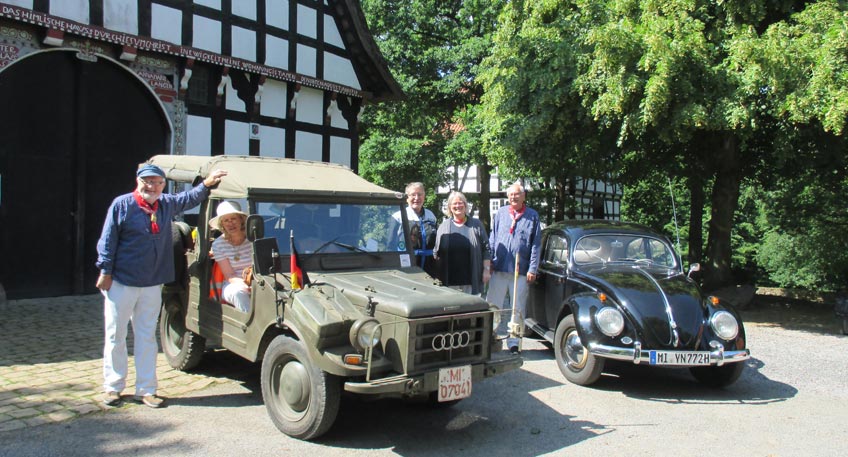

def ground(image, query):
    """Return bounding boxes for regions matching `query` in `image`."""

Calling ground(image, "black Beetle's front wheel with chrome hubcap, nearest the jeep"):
[554,314,604,386]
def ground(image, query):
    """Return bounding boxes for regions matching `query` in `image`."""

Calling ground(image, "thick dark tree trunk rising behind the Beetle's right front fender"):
[704,134,742,290]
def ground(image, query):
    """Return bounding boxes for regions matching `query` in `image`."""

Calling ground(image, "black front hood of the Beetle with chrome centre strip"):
[586,264,705,349]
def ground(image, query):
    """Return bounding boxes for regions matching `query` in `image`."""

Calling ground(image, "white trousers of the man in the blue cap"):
[101,280,162,396]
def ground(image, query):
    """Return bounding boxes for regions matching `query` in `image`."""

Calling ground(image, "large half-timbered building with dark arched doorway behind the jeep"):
[0,0,403,298]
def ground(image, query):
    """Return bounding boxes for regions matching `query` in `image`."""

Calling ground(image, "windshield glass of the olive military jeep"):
[255,201,406,255]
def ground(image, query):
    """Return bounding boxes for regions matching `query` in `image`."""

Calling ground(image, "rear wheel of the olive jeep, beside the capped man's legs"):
[159,298,206,371]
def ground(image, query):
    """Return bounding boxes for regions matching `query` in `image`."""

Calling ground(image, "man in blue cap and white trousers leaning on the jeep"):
[97,164,227,408]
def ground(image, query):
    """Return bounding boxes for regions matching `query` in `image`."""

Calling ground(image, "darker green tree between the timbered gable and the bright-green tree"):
[360,0,505,220]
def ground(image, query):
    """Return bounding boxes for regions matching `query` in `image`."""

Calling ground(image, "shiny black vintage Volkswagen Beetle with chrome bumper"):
[525,220,750,387]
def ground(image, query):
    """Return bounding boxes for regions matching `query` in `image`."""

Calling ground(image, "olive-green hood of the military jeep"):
[316,268,489,318]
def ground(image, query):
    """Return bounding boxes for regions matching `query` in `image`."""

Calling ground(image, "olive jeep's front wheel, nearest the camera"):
[262,335,341,440]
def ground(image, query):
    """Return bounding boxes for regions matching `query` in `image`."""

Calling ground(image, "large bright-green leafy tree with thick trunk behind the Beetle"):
[482,0,848,287]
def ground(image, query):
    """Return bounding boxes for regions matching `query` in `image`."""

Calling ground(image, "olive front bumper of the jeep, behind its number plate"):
[344,353,524,397]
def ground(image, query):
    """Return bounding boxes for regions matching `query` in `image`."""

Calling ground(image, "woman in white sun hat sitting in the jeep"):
[209,201,253,313]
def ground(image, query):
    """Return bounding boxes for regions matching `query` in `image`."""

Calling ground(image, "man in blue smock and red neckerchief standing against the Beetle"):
[486,182,542,352]
